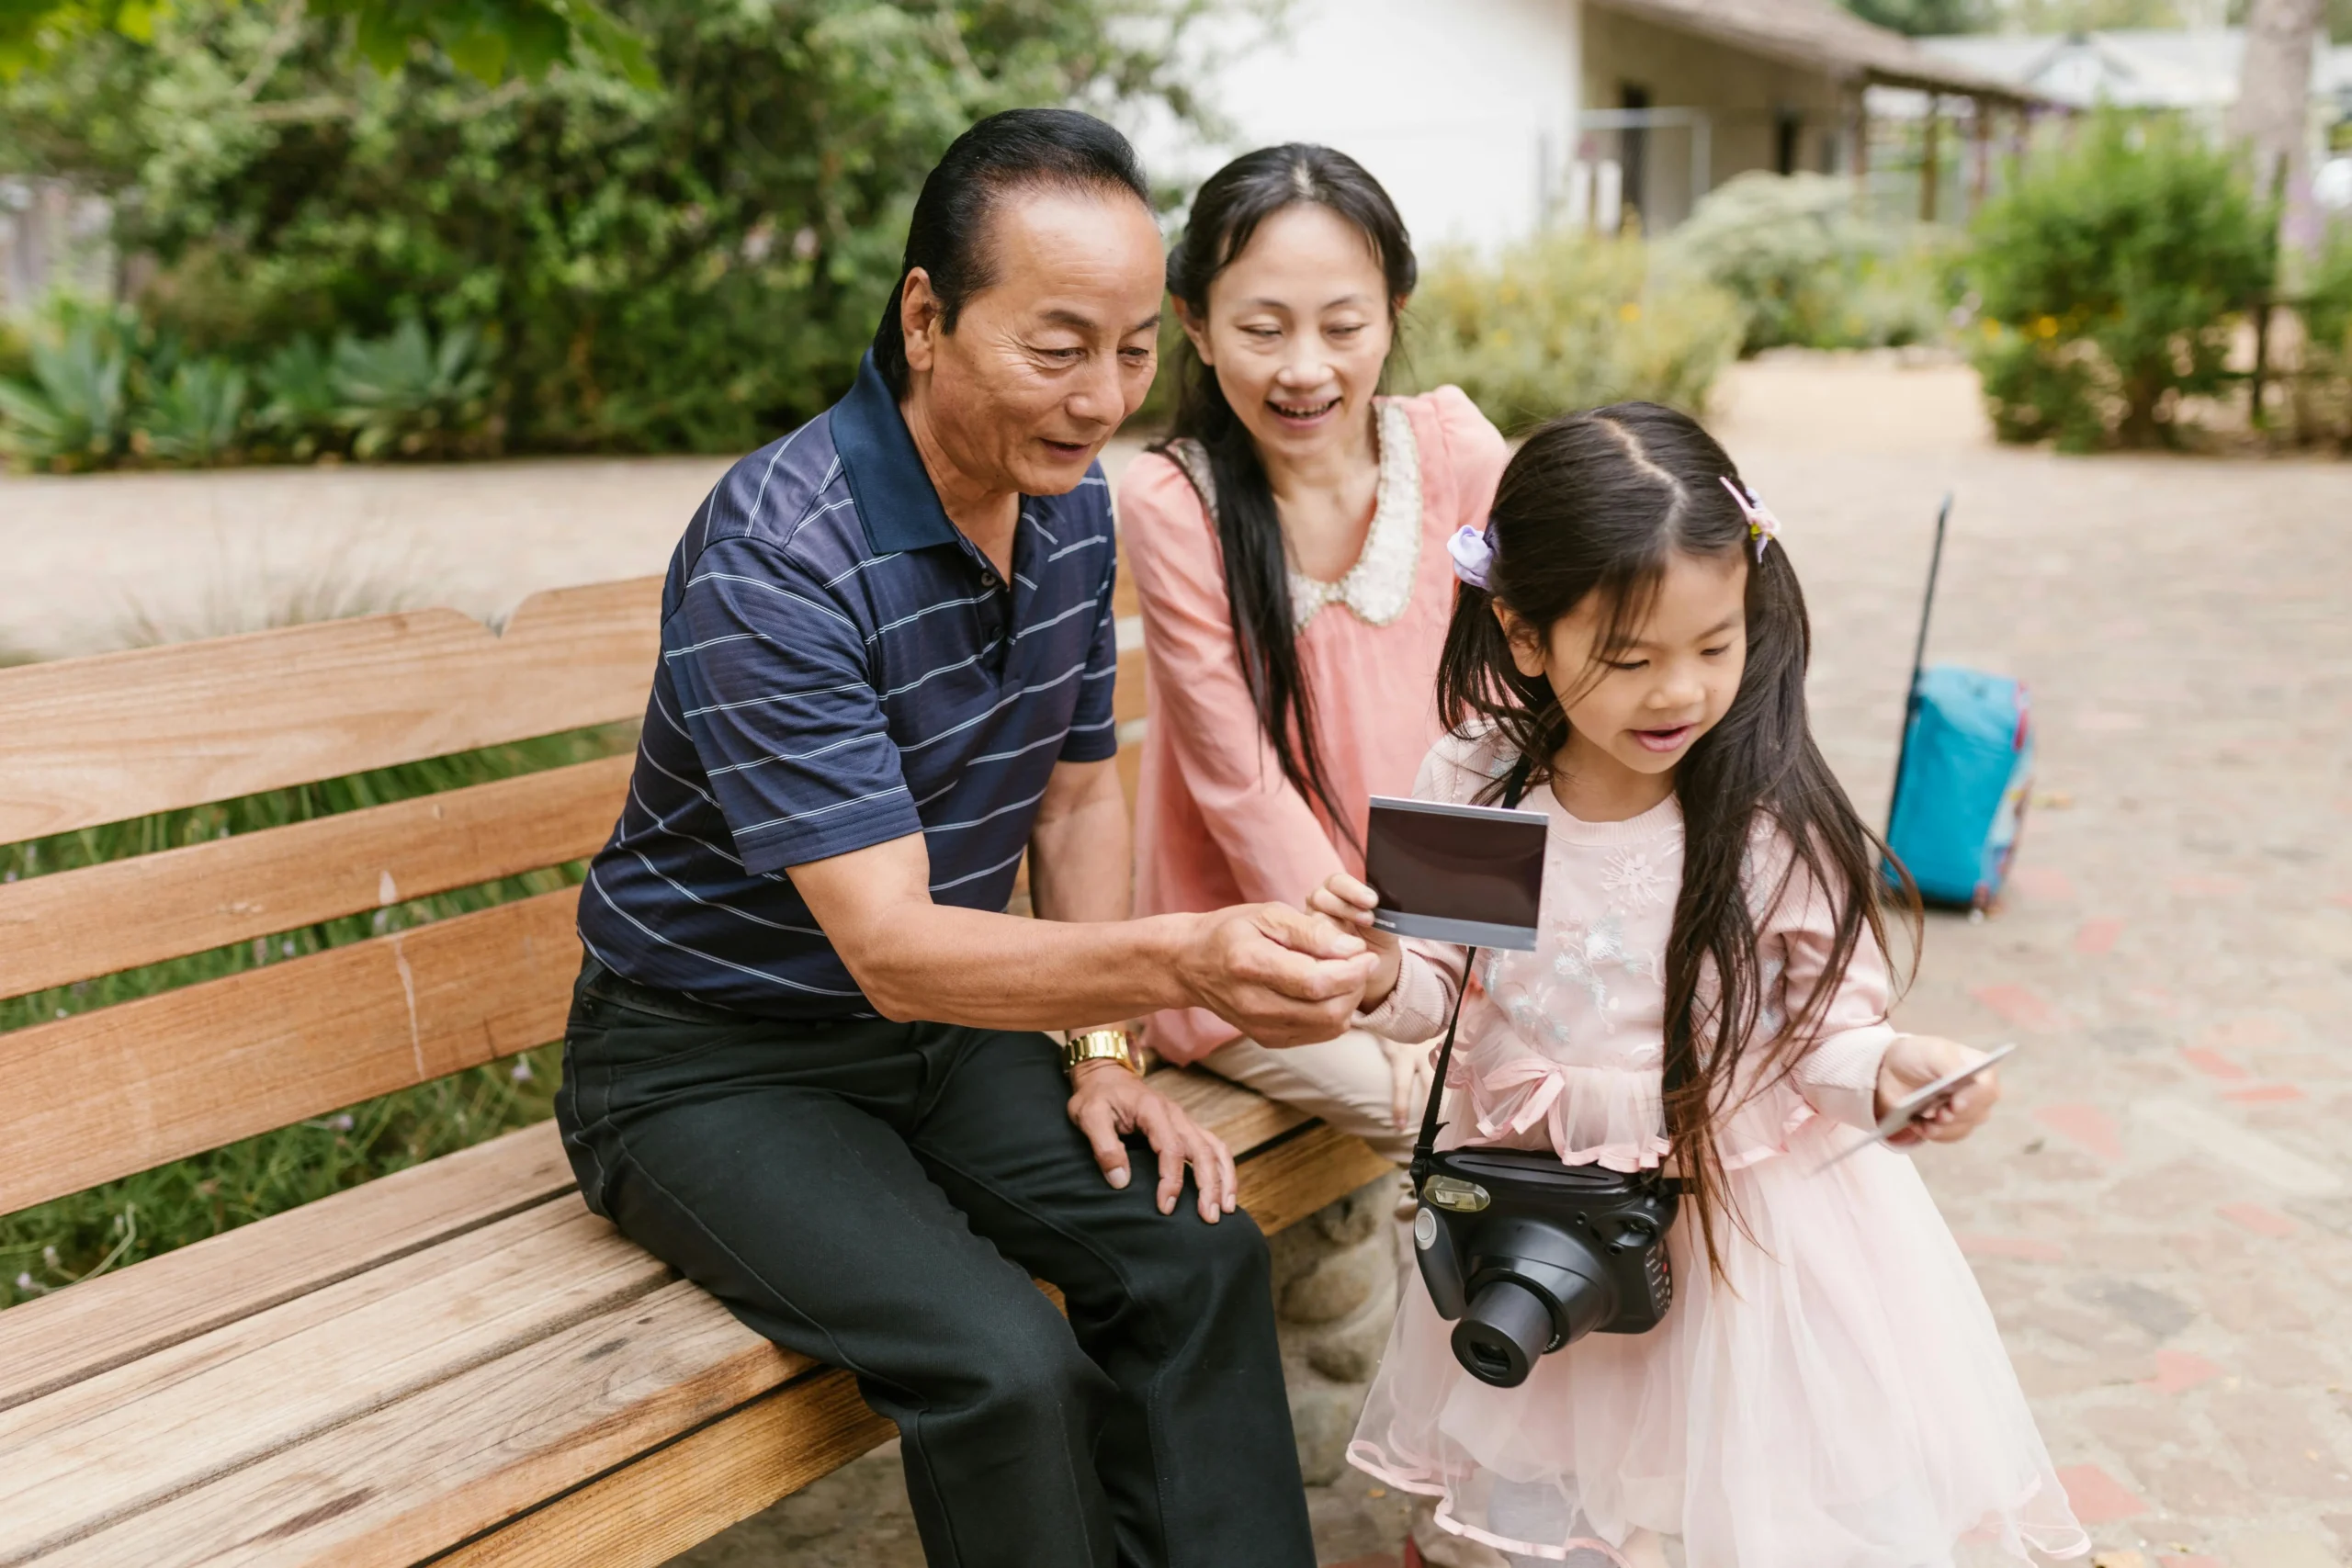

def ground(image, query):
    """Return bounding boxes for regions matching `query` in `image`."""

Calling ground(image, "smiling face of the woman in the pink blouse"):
[1179,202,1395,463]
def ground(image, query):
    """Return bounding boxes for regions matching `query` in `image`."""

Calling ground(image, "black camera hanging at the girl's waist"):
[1414,1147,1679,1389]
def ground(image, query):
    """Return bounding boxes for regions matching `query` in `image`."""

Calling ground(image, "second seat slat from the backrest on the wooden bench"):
[0,1197,673,1554]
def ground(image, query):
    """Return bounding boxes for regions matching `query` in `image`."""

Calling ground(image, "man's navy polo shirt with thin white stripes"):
[579,355,1120,1018]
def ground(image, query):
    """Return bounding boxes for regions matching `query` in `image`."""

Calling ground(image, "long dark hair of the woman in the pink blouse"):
[1152,141,1419,841]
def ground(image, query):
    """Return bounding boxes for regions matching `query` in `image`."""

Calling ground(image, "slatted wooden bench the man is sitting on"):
[0,581,1387,1568]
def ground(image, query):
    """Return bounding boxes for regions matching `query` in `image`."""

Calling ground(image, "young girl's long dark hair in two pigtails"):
[1437,402,1919,1269]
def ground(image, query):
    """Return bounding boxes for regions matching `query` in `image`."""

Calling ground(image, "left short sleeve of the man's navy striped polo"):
[656,538,922,874]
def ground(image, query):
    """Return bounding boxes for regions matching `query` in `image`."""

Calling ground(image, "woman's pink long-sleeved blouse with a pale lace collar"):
[1120,386,1510,1063]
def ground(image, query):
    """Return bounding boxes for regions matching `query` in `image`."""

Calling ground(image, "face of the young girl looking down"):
[1496,550,1747,776]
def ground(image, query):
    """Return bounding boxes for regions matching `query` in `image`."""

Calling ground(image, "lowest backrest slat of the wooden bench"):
[0,888,581,1213]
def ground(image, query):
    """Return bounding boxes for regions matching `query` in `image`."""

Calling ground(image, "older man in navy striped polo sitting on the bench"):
[558,110,1369,1568]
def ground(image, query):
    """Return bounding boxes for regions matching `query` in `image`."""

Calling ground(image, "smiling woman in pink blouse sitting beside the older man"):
[1120,143,1508,1161]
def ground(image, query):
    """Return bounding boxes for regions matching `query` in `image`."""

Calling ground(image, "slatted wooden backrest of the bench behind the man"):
[0,566,1143,1213]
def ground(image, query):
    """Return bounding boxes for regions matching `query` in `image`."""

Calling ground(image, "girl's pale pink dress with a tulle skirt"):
[1348,736,2088,1568]
